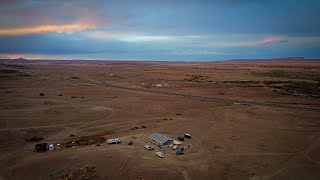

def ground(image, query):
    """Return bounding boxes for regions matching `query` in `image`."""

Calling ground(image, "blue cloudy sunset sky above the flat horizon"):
[0,0,320,61]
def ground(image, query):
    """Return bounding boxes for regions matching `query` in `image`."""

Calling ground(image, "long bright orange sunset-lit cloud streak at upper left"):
[0,23,96,36]
